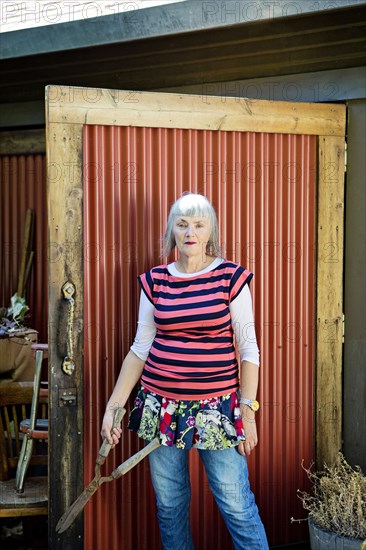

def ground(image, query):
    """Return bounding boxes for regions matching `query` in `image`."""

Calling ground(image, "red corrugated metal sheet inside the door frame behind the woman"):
[84,126,316,550]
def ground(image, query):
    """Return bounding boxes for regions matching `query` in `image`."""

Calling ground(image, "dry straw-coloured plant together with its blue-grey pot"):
[298,453,366,550]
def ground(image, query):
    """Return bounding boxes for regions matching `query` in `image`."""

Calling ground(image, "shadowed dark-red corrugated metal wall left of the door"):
[0,155,48,342]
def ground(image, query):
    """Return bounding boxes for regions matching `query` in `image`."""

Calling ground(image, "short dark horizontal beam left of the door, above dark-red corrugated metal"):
[0,129,46,155]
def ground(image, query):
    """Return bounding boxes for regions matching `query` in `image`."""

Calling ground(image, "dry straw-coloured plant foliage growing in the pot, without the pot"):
[298,453,366,540]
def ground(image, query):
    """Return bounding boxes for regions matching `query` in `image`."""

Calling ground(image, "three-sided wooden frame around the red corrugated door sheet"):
[46,86,346,550]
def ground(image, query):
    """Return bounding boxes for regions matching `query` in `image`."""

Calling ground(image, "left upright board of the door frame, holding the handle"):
[47,118,84,550]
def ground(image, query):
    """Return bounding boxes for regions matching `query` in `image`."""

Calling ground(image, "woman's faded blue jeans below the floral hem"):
[149,445,268,550]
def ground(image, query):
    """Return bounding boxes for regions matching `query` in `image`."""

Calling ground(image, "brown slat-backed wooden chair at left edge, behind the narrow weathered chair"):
[0,382,48,517]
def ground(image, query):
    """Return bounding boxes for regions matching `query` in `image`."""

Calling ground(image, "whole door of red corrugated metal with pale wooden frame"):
[47,86,345,550]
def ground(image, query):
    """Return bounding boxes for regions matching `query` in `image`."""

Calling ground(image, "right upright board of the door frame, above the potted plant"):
[315,136,345,467]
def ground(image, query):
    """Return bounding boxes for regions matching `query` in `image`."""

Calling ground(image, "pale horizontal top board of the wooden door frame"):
[46,86,345,136]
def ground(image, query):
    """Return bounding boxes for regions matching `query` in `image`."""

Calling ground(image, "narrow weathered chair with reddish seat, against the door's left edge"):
[15,344,48,493]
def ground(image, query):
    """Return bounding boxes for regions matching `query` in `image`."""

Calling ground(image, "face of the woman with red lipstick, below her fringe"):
[174,216,211,257]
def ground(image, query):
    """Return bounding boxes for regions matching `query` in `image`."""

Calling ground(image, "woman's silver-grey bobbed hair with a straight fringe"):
[164,193,221,256]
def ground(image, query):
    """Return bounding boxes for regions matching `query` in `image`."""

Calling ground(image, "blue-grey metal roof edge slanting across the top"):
[0,0,366,59]
